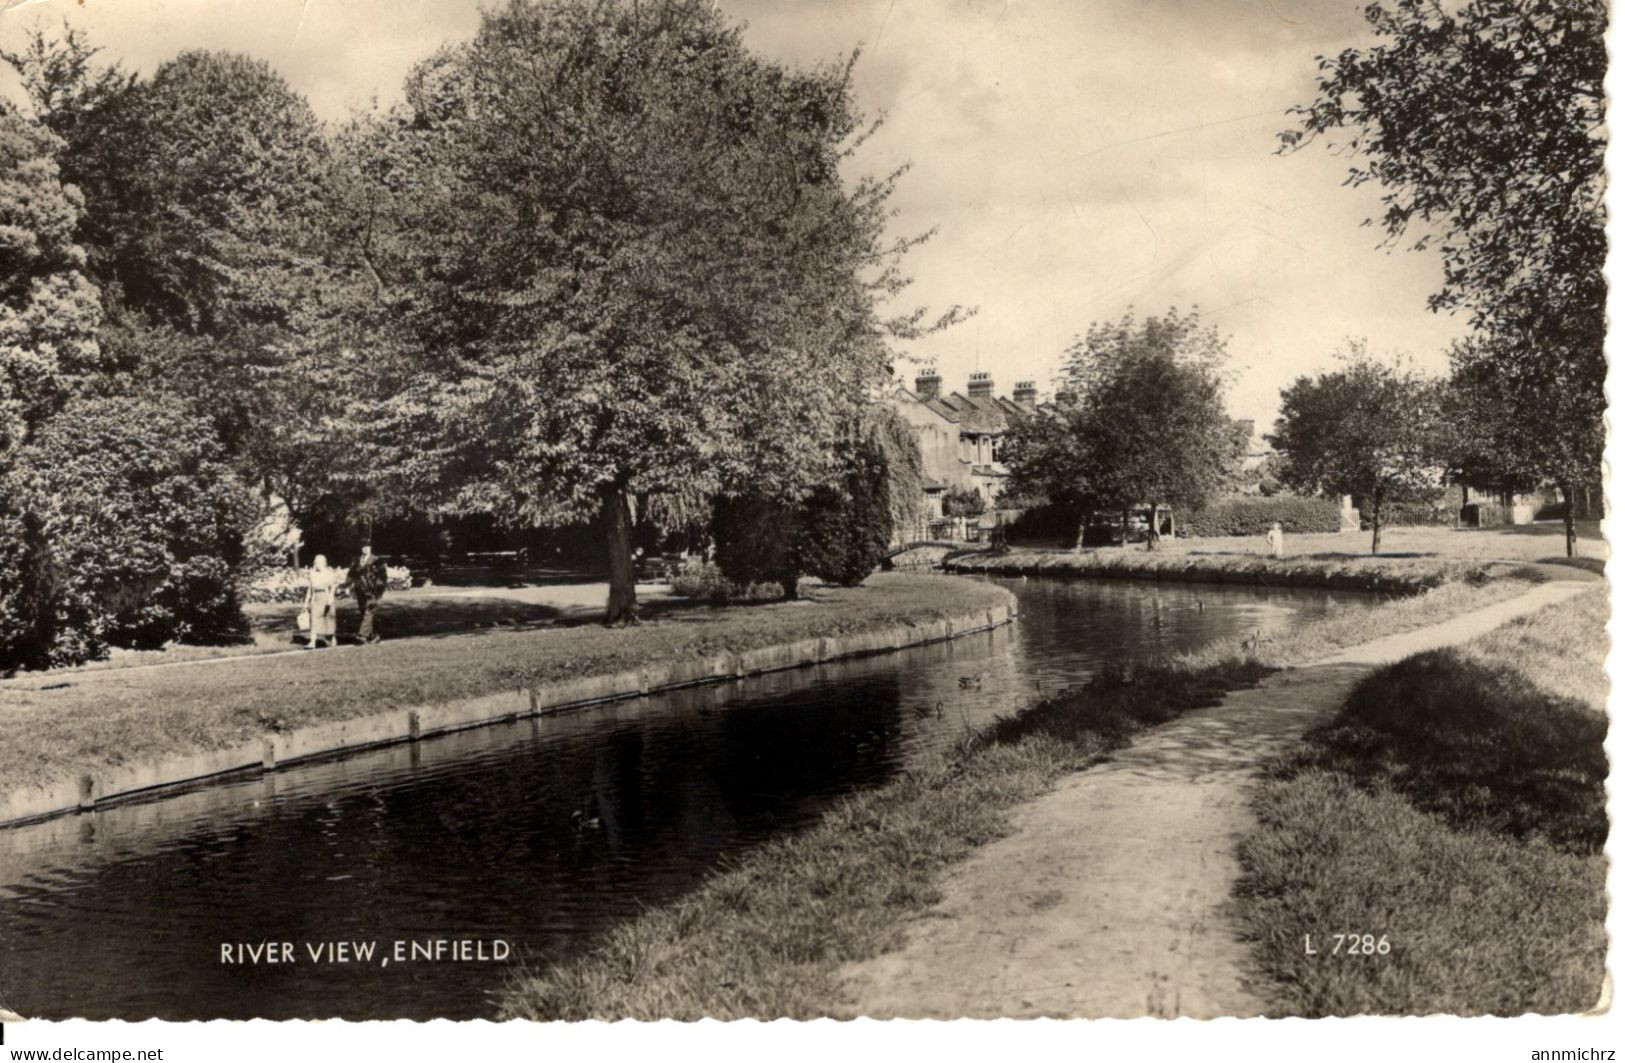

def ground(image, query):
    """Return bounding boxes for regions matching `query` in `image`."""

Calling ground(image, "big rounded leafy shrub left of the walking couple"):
[0,398,255,665]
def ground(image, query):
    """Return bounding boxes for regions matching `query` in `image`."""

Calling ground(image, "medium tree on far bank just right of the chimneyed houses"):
[1006,309,1242,549]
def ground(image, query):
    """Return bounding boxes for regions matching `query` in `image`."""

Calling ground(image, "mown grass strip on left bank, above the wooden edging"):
[0,574,1009,788]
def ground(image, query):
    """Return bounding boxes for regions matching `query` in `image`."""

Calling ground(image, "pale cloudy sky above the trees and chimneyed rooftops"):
[0,0,1466,427]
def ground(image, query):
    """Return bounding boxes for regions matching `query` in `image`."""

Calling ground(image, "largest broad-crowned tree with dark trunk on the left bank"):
[347,0,949,623]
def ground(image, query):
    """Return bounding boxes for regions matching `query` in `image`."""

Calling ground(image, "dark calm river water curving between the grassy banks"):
[0,580,1370,1019]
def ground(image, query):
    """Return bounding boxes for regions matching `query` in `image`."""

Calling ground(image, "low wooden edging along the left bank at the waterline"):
[0,600,1016,827]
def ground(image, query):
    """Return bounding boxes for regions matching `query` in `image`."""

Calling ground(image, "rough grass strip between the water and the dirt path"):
[504,580,1528,1019]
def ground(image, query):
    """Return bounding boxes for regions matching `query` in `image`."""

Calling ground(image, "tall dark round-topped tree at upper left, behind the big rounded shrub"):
[3,29,343,465]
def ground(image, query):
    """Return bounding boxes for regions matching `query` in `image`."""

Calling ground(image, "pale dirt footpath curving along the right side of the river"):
[843,582,1588,1017]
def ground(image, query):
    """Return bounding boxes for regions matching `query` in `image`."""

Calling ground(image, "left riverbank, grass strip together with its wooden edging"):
[0,574,1014,826]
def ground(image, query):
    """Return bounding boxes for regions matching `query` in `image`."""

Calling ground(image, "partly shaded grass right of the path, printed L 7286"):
[1238,585,1607,1016]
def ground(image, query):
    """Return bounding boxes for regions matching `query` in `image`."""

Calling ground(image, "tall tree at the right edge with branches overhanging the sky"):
[1282,0,1607,551]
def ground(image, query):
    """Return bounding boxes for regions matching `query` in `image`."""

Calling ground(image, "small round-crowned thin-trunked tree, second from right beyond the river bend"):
[1268,349,1443,554]
